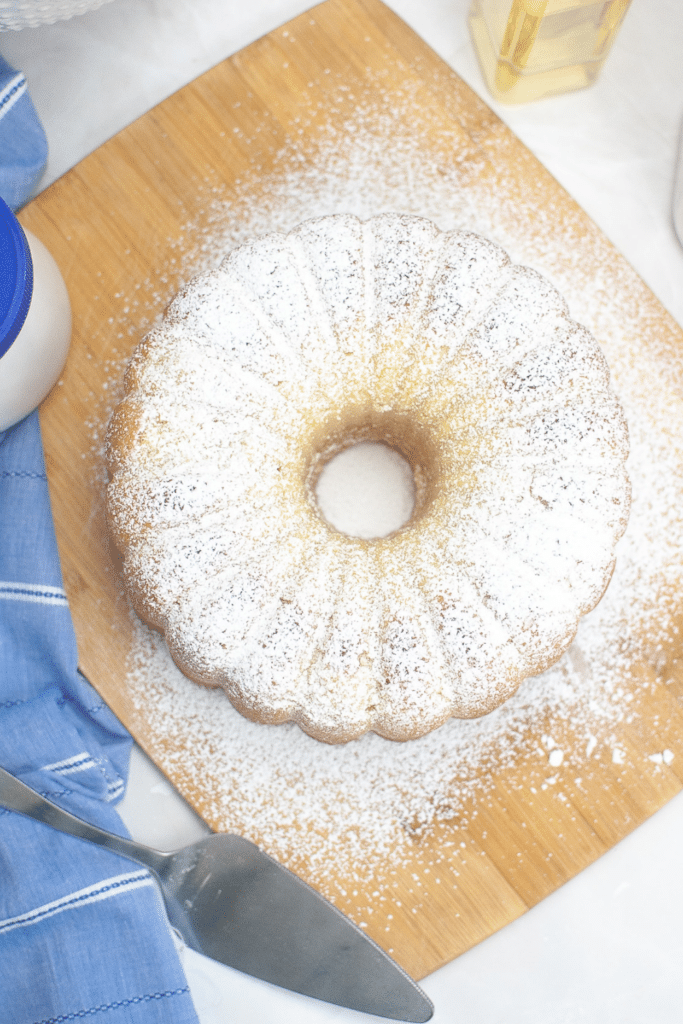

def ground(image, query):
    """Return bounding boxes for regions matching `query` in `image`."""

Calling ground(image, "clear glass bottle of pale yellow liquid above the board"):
[470,0,631,103]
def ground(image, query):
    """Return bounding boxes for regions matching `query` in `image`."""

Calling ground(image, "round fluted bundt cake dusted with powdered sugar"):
[108,214,630,742]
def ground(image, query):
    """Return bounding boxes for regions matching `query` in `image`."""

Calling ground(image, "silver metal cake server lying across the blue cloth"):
[0,768,434,1022]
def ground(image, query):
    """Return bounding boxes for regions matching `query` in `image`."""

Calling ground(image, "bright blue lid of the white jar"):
[0,199,33,358]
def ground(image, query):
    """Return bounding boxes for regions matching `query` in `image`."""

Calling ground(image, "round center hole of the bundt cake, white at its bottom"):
[315,441,415,541]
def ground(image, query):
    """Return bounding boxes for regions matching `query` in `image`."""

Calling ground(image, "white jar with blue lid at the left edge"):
[0,194,72,430]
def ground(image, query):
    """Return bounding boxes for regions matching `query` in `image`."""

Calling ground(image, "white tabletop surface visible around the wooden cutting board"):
[0,0,683,1024]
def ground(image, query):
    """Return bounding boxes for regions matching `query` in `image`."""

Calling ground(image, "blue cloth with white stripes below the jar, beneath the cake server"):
[0,413,198,1024]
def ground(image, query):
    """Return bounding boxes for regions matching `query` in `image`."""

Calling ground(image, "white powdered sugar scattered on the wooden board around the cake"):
[114,75,683,896]
